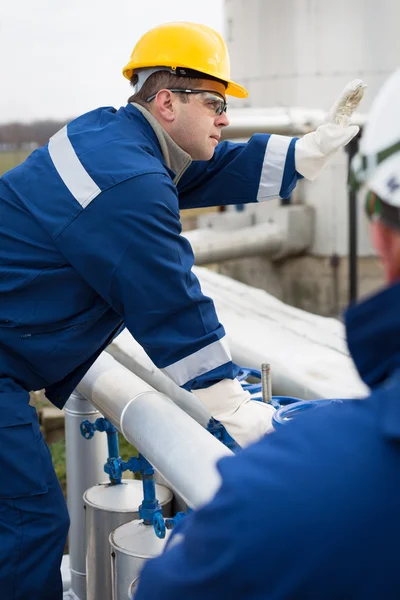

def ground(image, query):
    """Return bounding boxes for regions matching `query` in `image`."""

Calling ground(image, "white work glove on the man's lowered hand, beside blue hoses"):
[193,379,275,448]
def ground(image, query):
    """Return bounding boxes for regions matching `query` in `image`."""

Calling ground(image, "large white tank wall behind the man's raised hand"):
[224,0,400,256]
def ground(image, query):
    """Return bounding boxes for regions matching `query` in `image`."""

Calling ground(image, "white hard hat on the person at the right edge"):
[351,69,400,208]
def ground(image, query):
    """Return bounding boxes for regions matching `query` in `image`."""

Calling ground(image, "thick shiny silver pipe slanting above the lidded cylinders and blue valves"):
[78,353,231,508]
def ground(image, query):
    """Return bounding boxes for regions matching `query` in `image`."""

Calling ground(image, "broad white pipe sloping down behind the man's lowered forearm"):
[108,267,368,399]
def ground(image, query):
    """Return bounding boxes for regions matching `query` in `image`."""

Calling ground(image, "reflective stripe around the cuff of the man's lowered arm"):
[161,336,232,386]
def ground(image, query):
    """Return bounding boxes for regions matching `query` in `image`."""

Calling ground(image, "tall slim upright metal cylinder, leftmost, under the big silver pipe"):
[65,390,107,600]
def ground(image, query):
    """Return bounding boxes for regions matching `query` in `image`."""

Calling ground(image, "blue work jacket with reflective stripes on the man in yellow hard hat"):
[0,104,300,407]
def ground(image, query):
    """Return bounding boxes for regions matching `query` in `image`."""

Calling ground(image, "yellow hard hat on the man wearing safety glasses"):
[122,22,249,98]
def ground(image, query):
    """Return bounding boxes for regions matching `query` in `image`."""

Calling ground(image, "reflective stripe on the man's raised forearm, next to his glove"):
[257,135,292,202]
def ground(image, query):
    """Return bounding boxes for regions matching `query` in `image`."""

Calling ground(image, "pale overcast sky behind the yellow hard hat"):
[0,0,223,123]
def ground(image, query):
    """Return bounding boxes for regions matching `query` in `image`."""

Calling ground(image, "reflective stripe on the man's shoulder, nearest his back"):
[49,125,101,208]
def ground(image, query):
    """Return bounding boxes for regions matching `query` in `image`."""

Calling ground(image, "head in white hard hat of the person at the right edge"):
[352,69,400,283]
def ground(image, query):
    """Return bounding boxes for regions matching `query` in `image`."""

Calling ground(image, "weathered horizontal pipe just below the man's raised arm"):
[184,223,282,265]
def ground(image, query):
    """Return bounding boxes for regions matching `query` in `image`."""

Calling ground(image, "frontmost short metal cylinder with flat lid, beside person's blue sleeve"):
[110,520,171,600]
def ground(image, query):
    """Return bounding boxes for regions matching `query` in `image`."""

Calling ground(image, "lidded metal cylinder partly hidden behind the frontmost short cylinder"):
[84,479,172,600]
